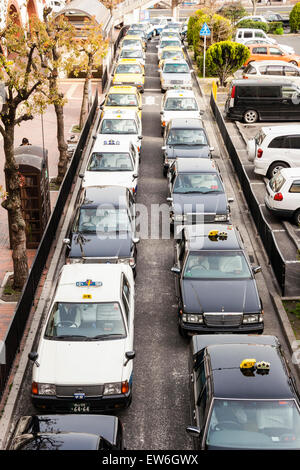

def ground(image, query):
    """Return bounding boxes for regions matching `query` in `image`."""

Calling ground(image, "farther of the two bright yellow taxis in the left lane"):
[112,59,145,93]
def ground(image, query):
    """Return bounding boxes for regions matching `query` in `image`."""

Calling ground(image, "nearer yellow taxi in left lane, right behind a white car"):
[100,85,142,119]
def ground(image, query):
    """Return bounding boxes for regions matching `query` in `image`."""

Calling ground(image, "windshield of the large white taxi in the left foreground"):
[45,302,126,341]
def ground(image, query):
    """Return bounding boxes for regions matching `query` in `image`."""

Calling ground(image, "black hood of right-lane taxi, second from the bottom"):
[182,279,260,313]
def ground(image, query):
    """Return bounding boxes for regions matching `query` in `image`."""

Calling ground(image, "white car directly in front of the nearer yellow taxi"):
[99,109,142,152]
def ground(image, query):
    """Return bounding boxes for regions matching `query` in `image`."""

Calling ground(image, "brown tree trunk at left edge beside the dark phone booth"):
[2,120,28,290]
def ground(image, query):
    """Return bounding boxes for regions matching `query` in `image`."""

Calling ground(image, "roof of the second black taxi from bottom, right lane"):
[184,224,243,251]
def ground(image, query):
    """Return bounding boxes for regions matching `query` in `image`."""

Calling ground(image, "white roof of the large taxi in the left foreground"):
[54,263,126,303]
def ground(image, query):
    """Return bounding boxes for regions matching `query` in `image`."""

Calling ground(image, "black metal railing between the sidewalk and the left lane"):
[0,92,98,397]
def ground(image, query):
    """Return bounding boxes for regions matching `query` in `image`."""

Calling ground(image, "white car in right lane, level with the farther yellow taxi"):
[159,59,193,92]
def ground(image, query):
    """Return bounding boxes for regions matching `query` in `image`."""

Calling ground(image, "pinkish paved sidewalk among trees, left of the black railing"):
[0,79,99,340]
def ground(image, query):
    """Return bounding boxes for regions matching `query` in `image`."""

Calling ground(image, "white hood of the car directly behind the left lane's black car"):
[82,171,137,190]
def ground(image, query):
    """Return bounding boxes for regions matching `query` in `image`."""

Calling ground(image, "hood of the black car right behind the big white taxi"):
[69,232,132,258]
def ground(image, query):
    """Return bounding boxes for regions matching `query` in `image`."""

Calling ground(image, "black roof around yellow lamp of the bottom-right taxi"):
[206,344,294,399]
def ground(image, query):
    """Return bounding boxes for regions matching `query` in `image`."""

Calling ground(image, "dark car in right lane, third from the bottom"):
[167,158,231,228]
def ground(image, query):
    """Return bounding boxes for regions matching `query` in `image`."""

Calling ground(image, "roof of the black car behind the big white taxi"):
[81,186,128,209]
